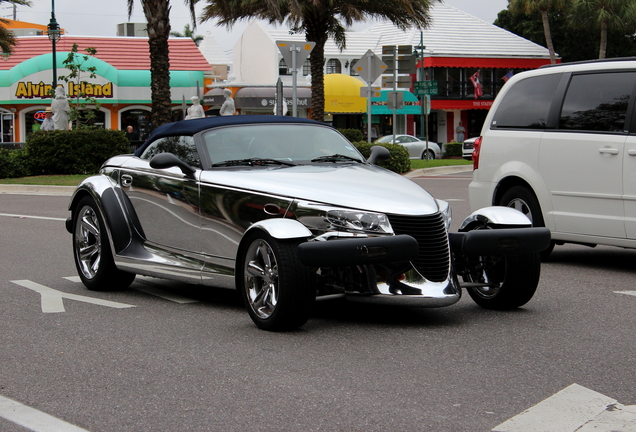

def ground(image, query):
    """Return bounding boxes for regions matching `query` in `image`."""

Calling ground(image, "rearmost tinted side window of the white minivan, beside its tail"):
[490,74,561,129]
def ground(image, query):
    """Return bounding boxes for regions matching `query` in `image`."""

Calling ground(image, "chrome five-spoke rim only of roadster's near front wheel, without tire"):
[243,239,279,319]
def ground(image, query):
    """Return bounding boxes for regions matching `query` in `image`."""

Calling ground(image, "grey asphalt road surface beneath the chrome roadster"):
[0,173,636,432]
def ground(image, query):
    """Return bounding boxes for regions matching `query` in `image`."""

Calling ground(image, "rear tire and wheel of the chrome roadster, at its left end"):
[73,196,135,291]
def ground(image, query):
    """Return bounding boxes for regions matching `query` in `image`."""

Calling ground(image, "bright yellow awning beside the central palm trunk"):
[325,74,367,114]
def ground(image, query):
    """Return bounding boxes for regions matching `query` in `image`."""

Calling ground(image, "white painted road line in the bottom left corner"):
[0,396,88,432]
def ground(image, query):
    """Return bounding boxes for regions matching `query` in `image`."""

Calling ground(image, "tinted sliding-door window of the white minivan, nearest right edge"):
[559,72,636,132]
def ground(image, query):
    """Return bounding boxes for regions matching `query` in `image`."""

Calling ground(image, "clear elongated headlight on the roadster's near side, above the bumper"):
[293,202,393,234]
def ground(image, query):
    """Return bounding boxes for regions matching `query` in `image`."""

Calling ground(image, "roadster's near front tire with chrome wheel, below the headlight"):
[236,231,316,331]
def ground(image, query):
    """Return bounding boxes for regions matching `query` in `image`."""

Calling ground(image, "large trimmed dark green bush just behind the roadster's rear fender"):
[25,128,130,175]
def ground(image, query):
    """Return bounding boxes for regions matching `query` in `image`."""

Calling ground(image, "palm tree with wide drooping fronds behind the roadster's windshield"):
[200,0,439,121]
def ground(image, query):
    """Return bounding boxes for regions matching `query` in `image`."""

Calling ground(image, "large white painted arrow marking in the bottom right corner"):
[492,384,636,432]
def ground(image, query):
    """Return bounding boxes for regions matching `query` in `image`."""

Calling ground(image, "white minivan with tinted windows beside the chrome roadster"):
[469,58,636,256]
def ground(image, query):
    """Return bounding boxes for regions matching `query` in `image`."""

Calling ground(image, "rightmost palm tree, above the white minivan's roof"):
[572,0,636,59]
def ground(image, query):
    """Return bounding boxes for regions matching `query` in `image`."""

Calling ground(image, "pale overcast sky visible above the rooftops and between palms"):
[0,0,508,51]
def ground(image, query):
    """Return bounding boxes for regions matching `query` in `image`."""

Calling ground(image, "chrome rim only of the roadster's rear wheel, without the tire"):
[73,205,102,279]
